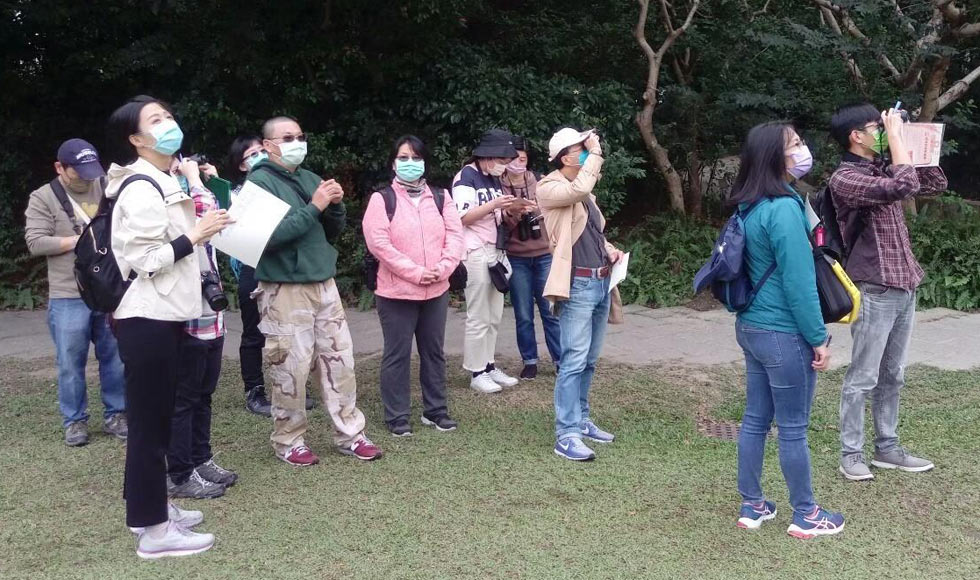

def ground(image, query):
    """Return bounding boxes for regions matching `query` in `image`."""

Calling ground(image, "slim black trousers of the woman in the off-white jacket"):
[116,318,184,527]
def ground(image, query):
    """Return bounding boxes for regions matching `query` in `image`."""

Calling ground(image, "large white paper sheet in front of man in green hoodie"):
[211,181,289,268]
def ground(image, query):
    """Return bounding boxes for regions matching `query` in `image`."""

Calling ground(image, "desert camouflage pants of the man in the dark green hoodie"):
[256,279,365,455]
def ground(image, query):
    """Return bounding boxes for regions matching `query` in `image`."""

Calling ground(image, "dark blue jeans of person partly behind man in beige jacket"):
[509,254,561,365]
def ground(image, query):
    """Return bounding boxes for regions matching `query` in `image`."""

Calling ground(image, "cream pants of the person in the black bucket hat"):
[463,244,506,373]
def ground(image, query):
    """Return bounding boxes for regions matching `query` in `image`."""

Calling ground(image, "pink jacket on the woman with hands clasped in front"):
[361,181,463,300]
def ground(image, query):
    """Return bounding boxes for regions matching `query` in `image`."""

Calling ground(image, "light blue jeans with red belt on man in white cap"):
[555,276,609,441]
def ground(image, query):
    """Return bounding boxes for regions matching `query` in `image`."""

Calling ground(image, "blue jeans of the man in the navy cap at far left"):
[48,298,126,427]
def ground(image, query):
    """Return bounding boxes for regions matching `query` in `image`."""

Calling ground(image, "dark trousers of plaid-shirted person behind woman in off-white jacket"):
[167,333,225,485]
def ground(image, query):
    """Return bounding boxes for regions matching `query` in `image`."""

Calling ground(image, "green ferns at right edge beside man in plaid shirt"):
[909,196,980,310]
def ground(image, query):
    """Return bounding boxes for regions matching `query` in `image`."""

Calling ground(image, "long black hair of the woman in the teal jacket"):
[728,121,794,205]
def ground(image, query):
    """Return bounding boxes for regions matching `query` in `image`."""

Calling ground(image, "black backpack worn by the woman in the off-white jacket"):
[75,175,164,312]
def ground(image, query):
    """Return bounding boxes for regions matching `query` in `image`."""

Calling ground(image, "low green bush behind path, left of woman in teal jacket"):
[613,214,718,307]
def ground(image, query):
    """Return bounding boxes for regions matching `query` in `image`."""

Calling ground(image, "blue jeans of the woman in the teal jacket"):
[735,322,817,514]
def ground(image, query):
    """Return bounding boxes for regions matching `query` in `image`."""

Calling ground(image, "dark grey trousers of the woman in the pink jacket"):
[375,292,449,426]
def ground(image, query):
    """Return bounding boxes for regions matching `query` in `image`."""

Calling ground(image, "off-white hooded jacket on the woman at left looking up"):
[106,159,201,321]
